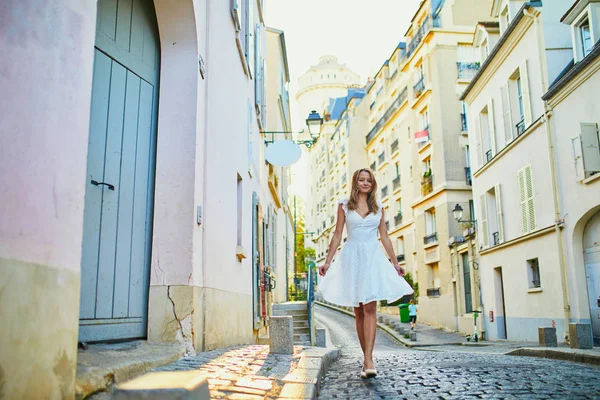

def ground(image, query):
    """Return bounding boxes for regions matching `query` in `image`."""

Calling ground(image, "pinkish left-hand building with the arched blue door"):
[0,0,289,398]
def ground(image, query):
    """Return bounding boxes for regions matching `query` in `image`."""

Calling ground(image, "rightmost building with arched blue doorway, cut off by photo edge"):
[542,0,600,345]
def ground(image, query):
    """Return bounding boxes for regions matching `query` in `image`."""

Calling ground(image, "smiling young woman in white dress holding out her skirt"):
[319,168,413,379]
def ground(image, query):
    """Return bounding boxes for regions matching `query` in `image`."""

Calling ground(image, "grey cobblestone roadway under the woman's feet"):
[315,306,600,400]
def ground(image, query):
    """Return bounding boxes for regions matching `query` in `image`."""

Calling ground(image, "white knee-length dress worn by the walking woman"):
[318,199,413,307]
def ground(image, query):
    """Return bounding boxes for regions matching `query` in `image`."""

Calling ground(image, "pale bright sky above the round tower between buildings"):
[265,0,420,197]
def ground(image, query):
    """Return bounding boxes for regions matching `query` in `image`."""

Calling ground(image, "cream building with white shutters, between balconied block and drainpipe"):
[462,0,573,340]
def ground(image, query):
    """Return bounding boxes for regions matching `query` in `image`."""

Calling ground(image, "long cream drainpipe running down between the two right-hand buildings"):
[523,7,571,342]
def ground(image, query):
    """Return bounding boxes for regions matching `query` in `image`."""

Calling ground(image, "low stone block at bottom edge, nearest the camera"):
[112,371,210,400]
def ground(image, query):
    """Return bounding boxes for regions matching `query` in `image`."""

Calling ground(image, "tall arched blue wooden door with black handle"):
[79,0,159,341]
